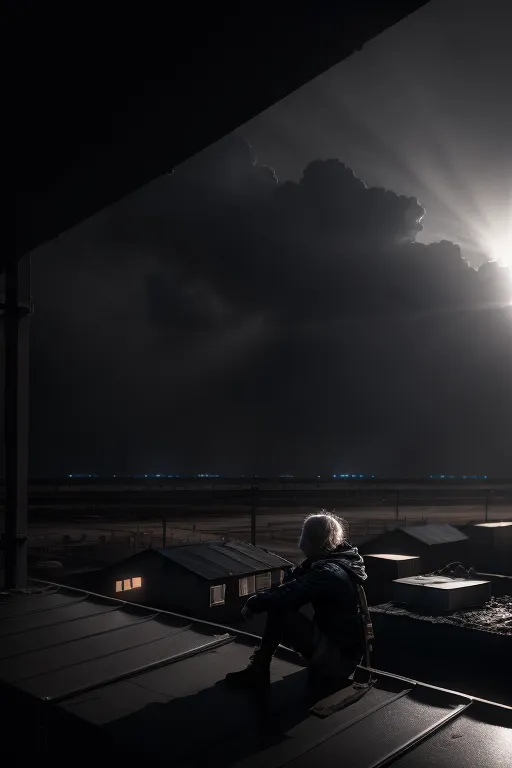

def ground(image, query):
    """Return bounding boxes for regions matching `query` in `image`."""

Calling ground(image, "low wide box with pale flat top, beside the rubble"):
[393,576,491,613]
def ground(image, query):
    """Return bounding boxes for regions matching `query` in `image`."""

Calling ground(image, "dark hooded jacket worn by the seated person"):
[247,544,367,660]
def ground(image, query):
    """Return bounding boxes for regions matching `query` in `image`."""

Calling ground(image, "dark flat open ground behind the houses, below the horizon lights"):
[7,504,512,569]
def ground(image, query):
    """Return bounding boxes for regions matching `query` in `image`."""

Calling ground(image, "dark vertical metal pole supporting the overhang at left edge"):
[4,256,32,589]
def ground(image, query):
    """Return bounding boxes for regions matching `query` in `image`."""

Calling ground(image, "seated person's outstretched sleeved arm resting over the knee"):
[246,568,332,613]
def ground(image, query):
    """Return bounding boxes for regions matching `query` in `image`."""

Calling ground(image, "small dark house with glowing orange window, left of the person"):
[83,541,291,623]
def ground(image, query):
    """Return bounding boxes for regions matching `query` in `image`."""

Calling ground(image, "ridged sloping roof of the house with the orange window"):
[156,541,291,579]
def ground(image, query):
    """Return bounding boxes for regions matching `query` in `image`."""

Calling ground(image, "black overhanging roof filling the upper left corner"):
[9,0,432,268]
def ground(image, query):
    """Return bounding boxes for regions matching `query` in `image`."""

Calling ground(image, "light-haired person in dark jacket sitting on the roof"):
[226,510,367,687]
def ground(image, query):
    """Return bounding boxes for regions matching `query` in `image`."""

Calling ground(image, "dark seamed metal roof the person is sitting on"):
[0,582,512,768]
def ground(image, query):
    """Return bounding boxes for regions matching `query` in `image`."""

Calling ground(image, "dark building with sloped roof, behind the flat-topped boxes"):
[360,523,471,573]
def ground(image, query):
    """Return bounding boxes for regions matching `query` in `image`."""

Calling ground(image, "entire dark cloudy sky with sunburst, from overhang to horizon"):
[17,0,512,476]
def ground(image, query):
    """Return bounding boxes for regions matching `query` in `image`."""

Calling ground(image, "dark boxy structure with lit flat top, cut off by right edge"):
[466,521,512,576]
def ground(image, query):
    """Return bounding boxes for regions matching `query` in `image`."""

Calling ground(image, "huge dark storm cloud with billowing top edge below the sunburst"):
[32,136,512,475]
